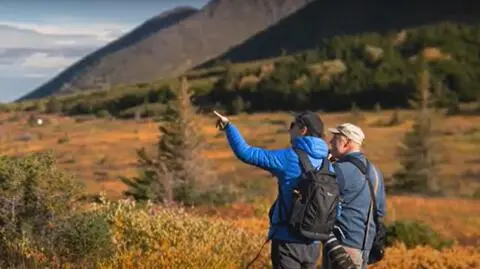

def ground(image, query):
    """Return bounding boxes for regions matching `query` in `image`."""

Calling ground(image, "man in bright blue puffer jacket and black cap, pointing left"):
[215,111,333,269]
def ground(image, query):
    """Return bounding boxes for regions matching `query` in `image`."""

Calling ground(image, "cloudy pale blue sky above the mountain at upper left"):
[0,0,208,103]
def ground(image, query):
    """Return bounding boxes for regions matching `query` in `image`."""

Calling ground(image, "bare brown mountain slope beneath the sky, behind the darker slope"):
[20,0,313,100]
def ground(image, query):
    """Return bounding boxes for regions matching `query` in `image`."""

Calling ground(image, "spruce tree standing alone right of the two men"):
[392,65,440,194]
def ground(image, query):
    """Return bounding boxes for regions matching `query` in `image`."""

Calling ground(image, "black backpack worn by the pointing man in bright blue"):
[279,148,340,241]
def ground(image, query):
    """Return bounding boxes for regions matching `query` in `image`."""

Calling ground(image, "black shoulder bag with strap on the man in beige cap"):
[342,156,387,264]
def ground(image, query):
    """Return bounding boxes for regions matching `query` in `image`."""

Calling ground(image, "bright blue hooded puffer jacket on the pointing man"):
[225,123,333,242]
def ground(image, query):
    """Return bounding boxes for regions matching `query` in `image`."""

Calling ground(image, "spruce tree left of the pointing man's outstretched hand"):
[122,78,214,204]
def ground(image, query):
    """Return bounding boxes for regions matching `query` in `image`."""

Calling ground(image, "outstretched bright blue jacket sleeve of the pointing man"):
[225,123,288,172]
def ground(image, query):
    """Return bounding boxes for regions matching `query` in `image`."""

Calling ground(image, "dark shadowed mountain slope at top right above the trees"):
[202,0,480,65]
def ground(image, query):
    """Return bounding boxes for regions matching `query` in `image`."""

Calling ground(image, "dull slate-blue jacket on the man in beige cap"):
[334,152,386,250]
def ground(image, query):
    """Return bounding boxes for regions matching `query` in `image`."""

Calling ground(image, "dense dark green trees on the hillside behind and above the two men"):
[209,23,480,112]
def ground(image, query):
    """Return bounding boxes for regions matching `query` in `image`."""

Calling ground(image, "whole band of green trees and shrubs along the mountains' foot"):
[7,22,480,118]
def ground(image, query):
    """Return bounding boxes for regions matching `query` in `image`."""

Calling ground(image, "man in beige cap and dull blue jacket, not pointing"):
[322,123,386,269]
